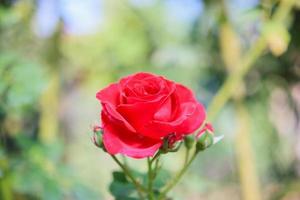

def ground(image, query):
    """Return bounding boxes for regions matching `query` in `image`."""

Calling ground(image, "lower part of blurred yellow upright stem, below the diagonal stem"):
[235,100,262,200]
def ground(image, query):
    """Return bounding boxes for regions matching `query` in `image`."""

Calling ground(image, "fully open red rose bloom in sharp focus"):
[96,72,206,158]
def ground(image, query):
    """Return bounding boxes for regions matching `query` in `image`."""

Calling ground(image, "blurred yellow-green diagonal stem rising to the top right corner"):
[208,0,295,121]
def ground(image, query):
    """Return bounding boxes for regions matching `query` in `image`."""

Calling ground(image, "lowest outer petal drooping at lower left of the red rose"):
[102,111,162,158]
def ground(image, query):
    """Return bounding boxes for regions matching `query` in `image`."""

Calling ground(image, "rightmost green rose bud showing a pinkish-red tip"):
[196,123,214,151]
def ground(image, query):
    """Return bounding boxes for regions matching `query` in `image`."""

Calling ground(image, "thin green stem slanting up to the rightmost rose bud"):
[158,151,198,200]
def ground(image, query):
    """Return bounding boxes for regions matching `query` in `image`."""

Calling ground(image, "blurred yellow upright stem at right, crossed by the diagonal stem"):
[220,0,262,200]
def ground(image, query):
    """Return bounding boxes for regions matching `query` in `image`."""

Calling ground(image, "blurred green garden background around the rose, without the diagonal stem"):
[0,0,300,200]
